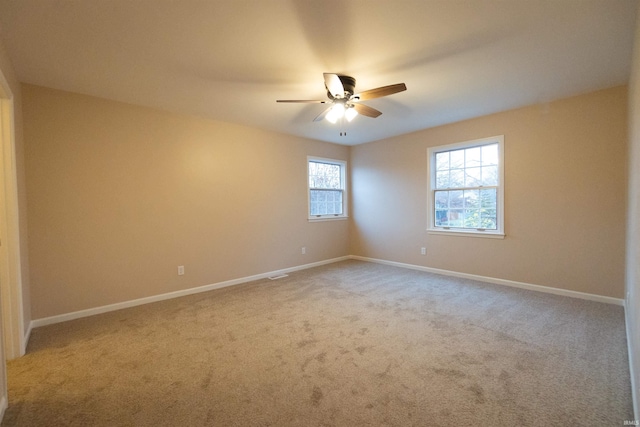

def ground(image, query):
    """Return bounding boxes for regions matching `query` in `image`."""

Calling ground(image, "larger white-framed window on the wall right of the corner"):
[428,136,504,238]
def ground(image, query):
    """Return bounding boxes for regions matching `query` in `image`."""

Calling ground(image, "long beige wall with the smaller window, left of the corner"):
[22,85,349,319]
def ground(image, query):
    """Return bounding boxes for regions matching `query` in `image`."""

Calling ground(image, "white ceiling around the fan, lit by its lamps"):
[0,0,637,145]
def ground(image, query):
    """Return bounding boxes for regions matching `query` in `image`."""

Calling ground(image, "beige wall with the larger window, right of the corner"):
[350,87,627,298]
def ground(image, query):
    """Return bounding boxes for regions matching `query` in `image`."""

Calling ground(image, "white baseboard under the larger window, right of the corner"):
[349,255,624,306]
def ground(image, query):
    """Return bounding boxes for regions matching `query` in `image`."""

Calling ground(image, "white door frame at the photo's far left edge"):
[0,70,26,360]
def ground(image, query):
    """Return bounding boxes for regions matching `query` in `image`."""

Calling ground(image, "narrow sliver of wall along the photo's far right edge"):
[626,5,640,419]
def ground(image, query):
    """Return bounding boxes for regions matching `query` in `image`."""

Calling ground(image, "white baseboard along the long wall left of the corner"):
[31,256,349,330]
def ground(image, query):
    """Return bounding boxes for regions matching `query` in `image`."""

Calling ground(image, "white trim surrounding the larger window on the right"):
[427,135,505,239]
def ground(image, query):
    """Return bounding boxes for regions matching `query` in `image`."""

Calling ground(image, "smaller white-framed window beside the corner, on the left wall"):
[307,157,347,220]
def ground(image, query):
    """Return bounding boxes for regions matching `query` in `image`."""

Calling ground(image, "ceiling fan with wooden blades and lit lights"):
[276,73,407,123]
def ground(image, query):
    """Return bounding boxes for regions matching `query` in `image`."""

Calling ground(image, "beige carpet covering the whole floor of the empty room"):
[2,261,633,426]
